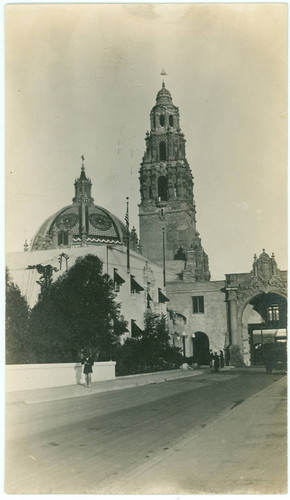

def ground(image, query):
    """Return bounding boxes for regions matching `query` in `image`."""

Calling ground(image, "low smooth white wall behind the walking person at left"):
[6,361,116,392]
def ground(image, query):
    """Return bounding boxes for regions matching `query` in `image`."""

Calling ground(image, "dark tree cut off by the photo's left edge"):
[6,269,29,365]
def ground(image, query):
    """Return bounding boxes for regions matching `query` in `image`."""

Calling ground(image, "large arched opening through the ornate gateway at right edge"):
[242,292,287,365]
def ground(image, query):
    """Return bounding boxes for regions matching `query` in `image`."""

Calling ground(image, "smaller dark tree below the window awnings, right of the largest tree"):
[116,311,183,375]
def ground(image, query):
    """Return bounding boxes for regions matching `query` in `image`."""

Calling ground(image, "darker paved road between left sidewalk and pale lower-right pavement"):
[5,372,285,494]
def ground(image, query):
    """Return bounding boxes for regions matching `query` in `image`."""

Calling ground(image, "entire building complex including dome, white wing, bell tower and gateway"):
[6,83,287,365]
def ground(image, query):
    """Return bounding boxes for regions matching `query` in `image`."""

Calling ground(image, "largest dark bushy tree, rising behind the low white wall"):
[29,254,126,363]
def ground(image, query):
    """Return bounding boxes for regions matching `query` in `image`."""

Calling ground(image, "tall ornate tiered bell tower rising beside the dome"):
[139,81,210,281]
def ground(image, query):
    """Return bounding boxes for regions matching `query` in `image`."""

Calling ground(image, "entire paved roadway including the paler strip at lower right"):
[5,370,287,494]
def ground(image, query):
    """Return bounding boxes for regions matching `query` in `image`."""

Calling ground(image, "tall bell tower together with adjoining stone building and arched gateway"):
[139,83,287,365]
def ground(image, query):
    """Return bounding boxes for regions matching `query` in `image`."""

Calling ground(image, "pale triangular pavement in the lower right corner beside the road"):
[98,377,287,495]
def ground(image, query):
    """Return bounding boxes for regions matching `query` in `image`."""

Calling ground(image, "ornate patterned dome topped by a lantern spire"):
[31,166,126,250]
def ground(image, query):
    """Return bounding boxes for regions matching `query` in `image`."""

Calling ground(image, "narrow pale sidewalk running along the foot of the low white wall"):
[6,366,212,405]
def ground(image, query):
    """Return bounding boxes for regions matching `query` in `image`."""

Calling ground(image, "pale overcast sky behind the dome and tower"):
[5,4,287,279]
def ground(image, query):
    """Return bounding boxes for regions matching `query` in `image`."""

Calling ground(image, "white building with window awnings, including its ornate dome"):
[6,165,167,336]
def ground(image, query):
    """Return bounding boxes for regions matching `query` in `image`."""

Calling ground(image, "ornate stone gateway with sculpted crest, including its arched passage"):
[226,250,287,365]
